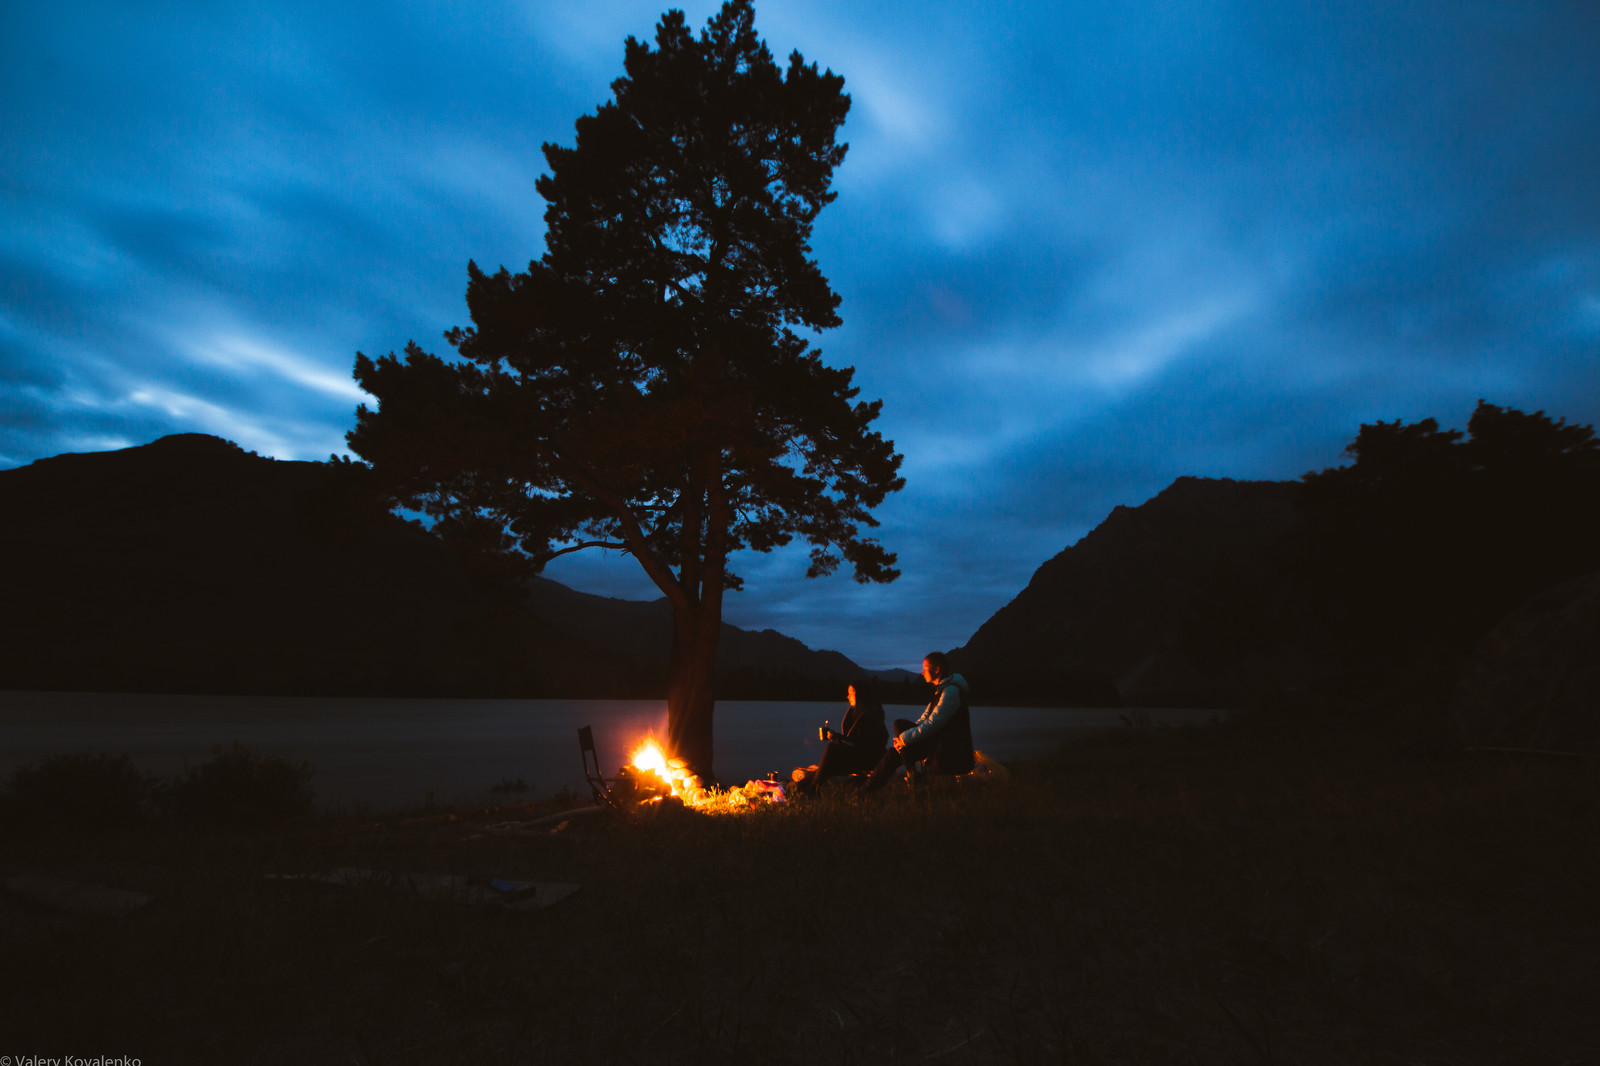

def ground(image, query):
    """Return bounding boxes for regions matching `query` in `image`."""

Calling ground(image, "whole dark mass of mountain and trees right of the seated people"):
[954,400,1600,717]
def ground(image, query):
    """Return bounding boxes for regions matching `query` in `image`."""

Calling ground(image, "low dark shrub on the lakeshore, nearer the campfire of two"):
[162,744,315,829]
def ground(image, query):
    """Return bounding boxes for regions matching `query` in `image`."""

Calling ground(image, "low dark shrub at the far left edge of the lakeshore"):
[0,752,150,831]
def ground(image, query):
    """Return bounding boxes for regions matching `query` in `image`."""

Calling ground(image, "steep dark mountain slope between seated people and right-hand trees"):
[952,477,1298,706]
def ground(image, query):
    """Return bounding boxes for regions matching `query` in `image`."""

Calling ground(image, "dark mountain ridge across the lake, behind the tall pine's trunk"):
[0,434,861,698]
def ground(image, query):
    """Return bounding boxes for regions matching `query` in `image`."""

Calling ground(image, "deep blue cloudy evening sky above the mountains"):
[0,0,1600,666]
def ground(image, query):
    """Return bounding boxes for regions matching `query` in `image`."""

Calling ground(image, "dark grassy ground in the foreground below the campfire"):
[0,697,1600,1066]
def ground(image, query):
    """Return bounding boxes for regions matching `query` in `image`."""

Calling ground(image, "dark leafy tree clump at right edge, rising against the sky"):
[1290,400,1600,659]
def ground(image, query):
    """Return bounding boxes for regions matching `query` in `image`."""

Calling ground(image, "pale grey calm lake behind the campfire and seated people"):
[0,691,1219,807]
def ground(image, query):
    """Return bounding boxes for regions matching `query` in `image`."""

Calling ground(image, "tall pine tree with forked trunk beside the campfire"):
[349,0,904,776]
